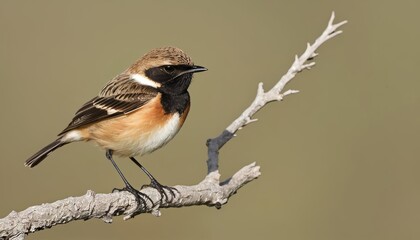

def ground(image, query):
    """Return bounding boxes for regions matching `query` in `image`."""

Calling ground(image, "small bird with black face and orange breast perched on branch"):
[25,47,207,206]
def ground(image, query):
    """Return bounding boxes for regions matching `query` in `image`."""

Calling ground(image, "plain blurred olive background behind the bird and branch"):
[0,0,420,240]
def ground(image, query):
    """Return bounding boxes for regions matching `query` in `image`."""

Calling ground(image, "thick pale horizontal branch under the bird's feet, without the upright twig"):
[0,163,261,239]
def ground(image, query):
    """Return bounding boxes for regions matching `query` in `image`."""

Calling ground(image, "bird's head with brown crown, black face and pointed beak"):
[126,47,207,95]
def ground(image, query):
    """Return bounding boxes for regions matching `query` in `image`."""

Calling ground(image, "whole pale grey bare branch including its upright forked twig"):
[0,12,347,239]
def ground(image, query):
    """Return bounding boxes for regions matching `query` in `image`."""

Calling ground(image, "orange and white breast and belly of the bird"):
[81,94,189,157]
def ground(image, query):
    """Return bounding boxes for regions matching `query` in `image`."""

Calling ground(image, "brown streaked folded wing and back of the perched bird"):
[58,74,158,135]
